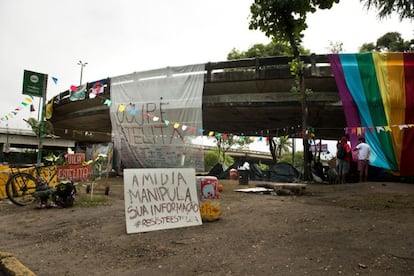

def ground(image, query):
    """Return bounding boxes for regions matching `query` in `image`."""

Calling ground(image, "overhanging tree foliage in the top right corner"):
[360,0,414,20]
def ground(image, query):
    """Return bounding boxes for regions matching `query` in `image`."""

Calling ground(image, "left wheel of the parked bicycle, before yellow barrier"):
[6,173,36,206]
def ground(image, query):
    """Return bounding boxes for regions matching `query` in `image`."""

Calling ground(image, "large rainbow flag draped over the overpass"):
[329,52,414,175]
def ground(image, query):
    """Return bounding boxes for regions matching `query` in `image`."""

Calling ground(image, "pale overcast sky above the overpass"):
[0,0,414,132]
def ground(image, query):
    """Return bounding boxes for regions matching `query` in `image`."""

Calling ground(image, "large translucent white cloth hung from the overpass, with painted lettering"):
[110,64,205,171]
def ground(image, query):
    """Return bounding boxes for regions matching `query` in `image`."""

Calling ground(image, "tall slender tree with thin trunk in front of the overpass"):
[249,0,339,180]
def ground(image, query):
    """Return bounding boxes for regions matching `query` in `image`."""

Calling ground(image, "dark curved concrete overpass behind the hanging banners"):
[50,55,346,143]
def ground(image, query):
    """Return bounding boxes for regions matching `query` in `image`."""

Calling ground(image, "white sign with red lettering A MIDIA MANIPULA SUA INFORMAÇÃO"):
[124,168,202,234]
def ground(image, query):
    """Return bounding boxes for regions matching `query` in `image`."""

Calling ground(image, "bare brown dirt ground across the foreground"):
[0,178,414,276]
